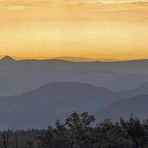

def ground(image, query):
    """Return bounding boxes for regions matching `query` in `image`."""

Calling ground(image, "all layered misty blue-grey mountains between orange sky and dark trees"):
[0,56,148,129]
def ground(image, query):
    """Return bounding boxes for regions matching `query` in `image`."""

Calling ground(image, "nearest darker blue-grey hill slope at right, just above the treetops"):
[96,95,148,120]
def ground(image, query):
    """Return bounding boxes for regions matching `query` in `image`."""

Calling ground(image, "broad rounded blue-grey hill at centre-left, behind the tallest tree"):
[0,82,114,129]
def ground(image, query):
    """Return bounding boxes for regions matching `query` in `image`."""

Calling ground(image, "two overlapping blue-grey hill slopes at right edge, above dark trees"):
[95,82,148,120]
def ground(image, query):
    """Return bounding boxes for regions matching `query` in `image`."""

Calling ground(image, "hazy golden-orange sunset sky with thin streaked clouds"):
[0,0,148,60]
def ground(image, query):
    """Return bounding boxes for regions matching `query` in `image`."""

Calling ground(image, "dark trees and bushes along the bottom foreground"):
[0,113,148,148]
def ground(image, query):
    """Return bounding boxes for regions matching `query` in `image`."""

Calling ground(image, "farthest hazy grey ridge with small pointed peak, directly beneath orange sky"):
[0,56,148,96]
